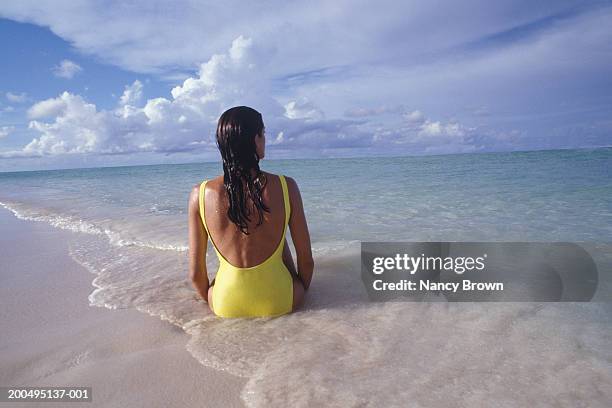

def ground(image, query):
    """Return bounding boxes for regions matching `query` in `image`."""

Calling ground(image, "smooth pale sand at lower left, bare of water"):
[0,209,245,408]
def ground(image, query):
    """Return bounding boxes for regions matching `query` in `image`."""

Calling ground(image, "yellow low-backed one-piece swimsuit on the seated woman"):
[200,176,293,317]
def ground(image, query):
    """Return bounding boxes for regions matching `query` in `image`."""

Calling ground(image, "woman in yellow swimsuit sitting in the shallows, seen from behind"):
[189,106,314,317]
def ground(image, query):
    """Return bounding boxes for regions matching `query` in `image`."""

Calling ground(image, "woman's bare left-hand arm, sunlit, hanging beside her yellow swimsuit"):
[188,185,209,302]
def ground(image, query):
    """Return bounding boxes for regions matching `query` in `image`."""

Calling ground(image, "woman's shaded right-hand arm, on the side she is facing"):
[286,177,314,290]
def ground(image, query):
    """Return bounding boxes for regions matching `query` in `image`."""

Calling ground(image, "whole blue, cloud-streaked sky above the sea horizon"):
[0,0,612,171]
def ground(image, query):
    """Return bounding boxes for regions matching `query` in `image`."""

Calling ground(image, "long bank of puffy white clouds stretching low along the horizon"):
[3,36,524,157]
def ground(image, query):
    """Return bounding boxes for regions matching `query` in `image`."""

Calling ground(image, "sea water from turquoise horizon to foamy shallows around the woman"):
[0,149,612,407]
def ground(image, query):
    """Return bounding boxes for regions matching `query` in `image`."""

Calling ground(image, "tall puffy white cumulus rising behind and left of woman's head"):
[4,36,283,156]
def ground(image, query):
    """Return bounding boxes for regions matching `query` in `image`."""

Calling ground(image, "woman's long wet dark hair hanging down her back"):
[217,106,269,235]
